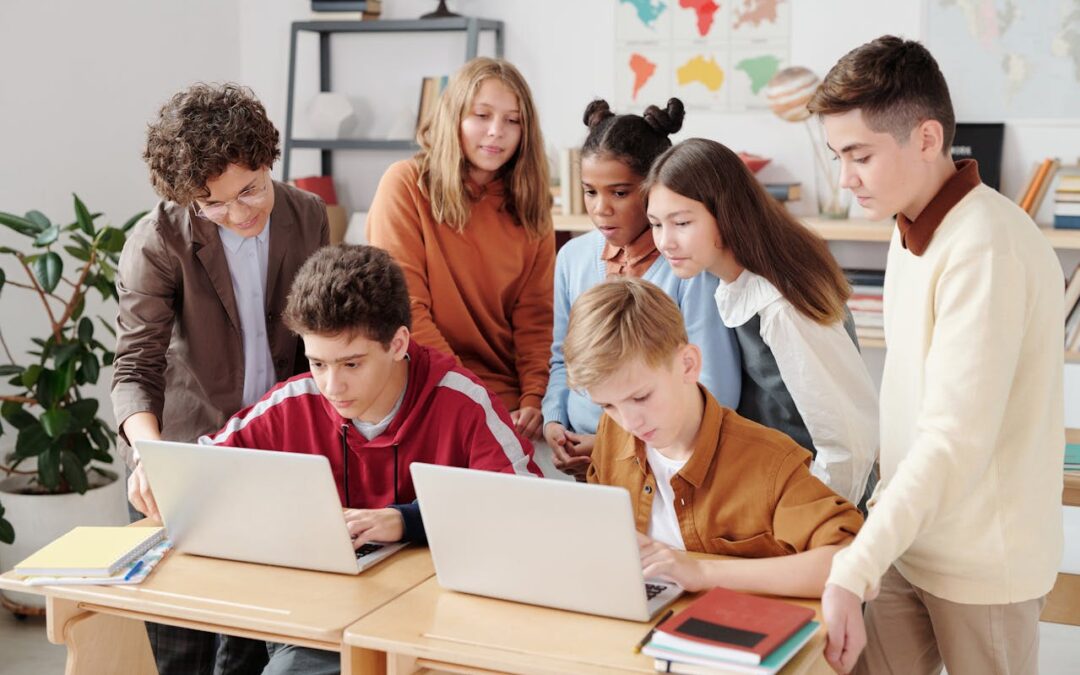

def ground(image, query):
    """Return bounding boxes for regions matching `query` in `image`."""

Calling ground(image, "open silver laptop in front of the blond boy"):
[411,463,683,621]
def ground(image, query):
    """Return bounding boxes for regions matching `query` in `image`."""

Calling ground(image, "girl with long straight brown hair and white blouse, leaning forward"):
[643,138,878,504]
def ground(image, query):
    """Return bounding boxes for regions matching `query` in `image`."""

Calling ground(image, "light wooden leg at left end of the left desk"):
[45,596,158,675]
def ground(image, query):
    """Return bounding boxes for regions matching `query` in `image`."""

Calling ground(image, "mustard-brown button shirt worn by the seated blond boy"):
[588,387,863,557]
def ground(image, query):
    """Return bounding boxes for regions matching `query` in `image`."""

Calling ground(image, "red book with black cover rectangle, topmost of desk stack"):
[652,588,814,664]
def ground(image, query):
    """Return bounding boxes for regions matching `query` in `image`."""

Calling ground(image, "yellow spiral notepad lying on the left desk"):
[15,527,165,577]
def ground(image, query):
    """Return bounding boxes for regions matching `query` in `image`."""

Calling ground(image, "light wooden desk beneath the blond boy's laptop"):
[341,578,833,675]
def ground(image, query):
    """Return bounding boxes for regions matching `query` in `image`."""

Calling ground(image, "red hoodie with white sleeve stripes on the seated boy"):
[199,342,541,531]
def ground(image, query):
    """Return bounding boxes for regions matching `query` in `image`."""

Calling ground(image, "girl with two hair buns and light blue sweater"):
[543,98,740,475]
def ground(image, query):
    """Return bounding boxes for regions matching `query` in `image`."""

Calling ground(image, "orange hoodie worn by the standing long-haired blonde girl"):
[367,160,555,410]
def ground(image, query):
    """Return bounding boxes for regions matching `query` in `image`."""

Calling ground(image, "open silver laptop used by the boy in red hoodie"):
[135,441,406,575]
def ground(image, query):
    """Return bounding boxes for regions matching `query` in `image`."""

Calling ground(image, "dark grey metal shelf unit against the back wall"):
[282,16,503,180]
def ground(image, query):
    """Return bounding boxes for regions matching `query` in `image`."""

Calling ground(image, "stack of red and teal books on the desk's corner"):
[642,588,820,674]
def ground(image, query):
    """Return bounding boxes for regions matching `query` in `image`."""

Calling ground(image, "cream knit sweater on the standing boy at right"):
[828,185,1065,604]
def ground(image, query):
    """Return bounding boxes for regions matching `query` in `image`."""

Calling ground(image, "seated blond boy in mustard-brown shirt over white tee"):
[564,278,863,597]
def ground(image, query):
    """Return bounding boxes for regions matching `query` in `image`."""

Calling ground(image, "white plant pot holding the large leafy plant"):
[0,474,129,607]
